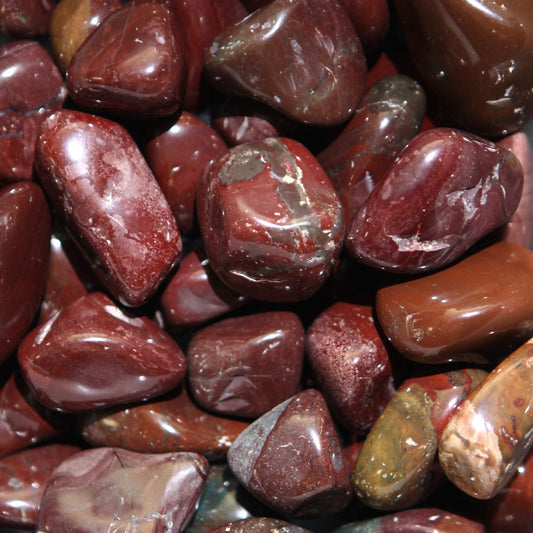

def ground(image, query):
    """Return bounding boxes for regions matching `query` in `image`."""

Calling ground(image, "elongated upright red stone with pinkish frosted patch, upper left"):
[36,111,182,306]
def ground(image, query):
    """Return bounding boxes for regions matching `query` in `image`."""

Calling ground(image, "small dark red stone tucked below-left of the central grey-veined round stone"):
[159,248,249,330]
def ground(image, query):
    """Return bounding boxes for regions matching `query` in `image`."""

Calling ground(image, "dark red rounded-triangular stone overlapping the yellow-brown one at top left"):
[66,2,187,117]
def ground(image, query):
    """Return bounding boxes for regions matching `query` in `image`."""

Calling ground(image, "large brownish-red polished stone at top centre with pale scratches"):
[205,0,366,126]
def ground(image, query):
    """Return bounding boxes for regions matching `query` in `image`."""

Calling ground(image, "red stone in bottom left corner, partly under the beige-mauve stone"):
[0,444,81,528]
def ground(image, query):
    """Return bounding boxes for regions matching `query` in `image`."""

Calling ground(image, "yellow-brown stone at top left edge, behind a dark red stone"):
[50,0,122,73]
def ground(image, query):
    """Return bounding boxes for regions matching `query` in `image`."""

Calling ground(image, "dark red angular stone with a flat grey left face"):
[228,389,351,518]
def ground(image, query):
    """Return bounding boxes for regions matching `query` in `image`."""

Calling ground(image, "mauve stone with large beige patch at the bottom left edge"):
[37,448,208,533]
